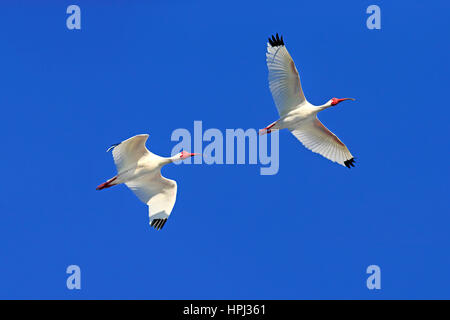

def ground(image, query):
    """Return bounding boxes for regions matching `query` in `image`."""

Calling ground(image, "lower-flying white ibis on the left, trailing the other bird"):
[97,134,197,230]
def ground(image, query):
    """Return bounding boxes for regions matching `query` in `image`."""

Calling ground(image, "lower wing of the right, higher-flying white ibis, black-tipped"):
[290,117,355,168]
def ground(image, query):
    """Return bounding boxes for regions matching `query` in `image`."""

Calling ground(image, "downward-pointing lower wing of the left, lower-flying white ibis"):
[125,173,177,230]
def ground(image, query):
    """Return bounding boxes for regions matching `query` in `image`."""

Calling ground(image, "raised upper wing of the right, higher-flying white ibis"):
[266,34,306,117]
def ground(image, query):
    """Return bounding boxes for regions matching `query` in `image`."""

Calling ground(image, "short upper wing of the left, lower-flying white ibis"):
[108,134,152,173]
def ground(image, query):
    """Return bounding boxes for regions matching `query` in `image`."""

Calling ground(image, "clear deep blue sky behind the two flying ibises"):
[0,0,450,299]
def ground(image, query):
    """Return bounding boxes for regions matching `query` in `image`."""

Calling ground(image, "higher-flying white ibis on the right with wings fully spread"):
[259,33,355,168]
